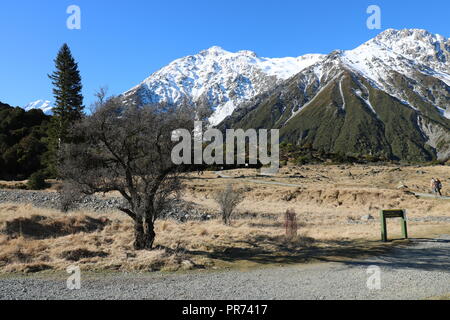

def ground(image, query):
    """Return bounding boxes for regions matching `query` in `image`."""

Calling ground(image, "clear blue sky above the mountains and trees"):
[0,0,450,106]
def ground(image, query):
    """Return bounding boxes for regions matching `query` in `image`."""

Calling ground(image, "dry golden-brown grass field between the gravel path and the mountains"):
[0,165,450,273]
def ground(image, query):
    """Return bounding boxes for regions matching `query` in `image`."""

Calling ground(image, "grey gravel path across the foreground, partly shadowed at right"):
[0,236,450,300]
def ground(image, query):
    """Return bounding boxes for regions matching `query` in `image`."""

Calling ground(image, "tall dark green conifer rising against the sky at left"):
[47,44,84,176]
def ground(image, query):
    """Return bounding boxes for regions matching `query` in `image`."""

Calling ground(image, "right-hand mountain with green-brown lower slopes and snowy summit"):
[220,29,450,161]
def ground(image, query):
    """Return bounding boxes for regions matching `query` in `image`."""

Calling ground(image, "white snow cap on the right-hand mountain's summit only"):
[341,29,450,119]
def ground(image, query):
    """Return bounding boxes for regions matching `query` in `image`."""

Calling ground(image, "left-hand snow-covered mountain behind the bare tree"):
[124,47,324,125]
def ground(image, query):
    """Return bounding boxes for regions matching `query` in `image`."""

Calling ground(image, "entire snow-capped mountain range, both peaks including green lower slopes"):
[123,29,450,160]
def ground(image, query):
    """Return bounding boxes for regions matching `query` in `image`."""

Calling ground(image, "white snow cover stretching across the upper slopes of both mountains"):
[123,29,450,125]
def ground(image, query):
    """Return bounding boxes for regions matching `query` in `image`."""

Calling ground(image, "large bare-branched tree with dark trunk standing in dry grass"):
[60,93,194,250]
